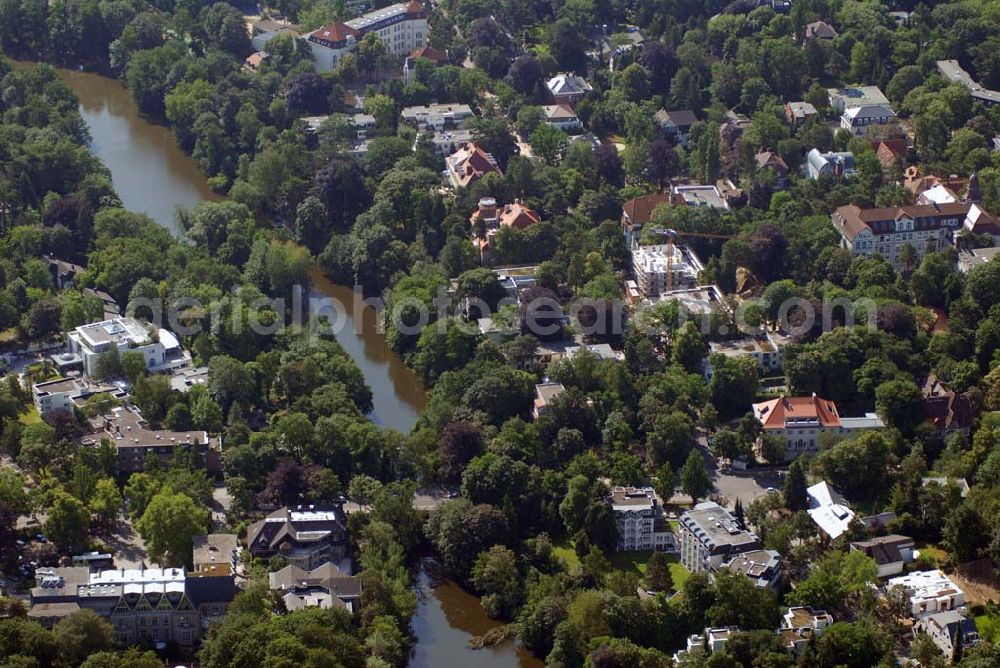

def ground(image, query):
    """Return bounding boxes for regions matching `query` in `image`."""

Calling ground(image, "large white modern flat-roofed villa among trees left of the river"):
[68,318,190,376]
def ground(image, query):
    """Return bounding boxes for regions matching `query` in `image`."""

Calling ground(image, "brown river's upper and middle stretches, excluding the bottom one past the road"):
[8,59,427,434]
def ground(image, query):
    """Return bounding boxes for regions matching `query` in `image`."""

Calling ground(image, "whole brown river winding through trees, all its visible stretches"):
[8,59,542,668]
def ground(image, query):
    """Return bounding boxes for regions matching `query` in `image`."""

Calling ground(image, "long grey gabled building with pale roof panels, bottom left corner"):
[28,566,236,647]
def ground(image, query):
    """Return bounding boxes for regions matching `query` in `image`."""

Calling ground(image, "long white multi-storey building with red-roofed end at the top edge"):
[305,0,427,72]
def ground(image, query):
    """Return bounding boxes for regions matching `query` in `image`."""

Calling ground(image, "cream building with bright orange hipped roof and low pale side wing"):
[753,394,885,461]
